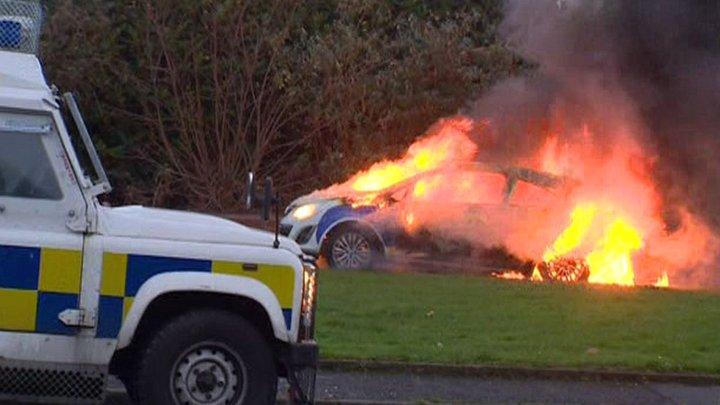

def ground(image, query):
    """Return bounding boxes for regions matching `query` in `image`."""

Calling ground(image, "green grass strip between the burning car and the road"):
[317,271,720,374]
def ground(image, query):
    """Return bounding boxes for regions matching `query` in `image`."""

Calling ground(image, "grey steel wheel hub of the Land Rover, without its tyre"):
[171,344,246,405]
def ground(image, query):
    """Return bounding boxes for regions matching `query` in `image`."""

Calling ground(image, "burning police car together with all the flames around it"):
[281,109,720,287]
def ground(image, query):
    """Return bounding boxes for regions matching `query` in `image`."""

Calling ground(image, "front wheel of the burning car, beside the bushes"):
[323,224,382,270]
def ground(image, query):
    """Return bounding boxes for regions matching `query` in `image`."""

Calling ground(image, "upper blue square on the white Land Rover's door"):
[0,246,40,290]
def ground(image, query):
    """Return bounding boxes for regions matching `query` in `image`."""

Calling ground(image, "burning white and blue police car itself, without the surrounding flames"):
[280,163,586,274]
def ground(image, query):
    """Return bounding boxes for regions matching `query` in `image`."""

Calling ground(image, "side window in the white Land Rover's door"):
[0,132,62,200]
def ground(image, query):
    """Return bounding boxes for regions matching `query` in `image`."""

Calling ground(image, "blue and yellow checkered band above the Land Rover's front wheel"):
[97,253,295,338]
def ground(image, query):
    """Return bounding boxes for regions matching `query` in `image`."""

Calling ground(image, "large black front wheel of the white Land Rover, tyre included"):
[134,310,277,405]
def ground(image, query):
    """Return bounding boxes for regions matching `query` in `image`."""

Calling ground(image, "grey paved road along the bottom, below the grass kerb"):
[102,372,720,405]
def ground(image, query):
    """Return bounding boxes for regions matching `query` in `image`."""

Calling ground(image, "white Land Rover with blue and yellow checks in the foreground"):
[0,0,317,405]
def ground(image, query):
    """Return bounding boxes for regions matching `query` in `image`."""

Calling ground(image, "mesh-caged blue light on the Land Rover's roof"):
[0,0,44,55]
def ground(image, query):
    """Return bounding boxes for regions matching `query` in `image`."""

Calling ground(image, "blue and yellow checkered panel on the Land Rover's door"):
[0,246,82,335]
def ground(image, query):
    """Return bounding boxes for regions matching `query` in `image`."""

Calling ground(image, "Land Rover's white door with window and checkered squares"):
[0,109,87,363]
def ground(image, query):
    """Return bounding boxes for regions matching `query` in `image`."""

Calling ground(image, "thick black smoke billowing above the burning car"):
[466,0,720,230]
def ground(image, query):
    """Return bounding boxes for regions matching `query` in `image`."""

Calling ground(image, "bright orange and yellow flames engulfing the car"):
[318,111,720,286]
